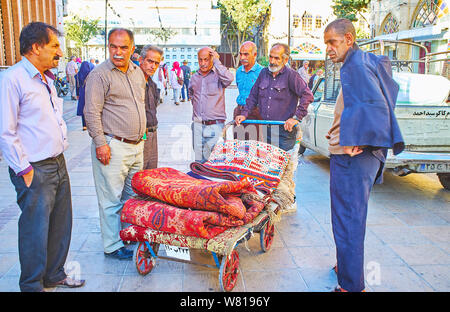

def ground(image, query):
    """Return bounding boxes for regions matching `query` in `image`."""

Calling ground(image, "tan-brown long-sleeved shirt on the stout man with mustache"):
[84,59,146,147]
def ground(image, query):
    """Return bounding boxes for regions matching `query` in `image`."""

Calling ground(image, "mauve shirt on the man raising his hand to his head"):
[189,58,234,121]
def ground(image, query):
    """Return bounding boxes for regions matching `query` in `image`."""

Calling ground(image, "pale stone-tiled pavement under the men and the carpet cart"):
[0,88,450,292]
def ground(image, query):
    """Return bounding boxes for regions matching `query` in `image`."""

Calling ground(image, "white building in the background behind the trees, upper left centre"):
[68,0,220,69]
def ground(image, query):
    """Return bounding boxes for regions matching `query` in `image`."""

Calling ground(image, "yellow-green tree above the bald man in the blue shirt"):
[218,0,270,67]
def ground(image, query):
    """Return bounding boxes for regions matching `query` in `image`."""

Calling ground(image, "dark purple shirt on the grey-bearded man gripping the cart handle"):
[241,66,314,121]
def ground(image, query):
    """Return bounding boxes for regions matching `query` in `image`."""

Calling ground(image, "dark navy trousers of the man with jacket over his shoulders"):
[330,149,382,292]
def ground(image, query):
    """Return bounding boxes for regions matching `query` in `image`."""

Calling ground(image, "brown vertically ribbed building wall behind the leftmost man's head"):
[0,0,63,68]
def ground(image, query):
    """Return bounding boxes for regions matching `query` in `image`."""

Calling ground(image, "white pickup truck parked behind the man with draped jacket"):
[299,41,450,190]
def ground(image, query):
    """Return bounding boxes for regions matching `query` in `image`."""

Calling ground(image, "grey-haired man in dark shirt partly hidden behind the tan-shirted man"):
[139,45,164,169]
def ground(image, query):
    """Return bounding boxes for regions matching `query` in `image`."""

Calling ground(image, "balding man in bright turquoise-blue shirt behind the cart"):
[233,41,263,140]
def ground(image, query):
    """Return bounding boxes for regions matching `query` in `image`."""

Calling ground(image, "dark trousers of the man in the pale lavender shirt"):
[9,154,72,291]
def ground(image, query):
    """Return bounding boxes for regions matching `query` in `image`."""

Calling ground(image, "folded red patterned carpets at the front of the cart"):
[121,168,264,239]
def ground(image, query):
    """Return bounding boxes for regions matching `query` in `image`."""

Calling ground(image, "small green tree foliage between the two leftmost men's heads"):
[64,15,100,48]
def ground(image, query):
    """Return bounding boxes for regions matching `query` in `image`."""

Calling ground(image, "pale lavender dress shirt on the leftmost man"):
[0,57,68,175]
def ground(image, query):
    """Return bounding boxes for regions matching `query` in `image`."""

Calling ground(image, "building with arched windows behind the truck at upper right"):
[370,0,450,77]
